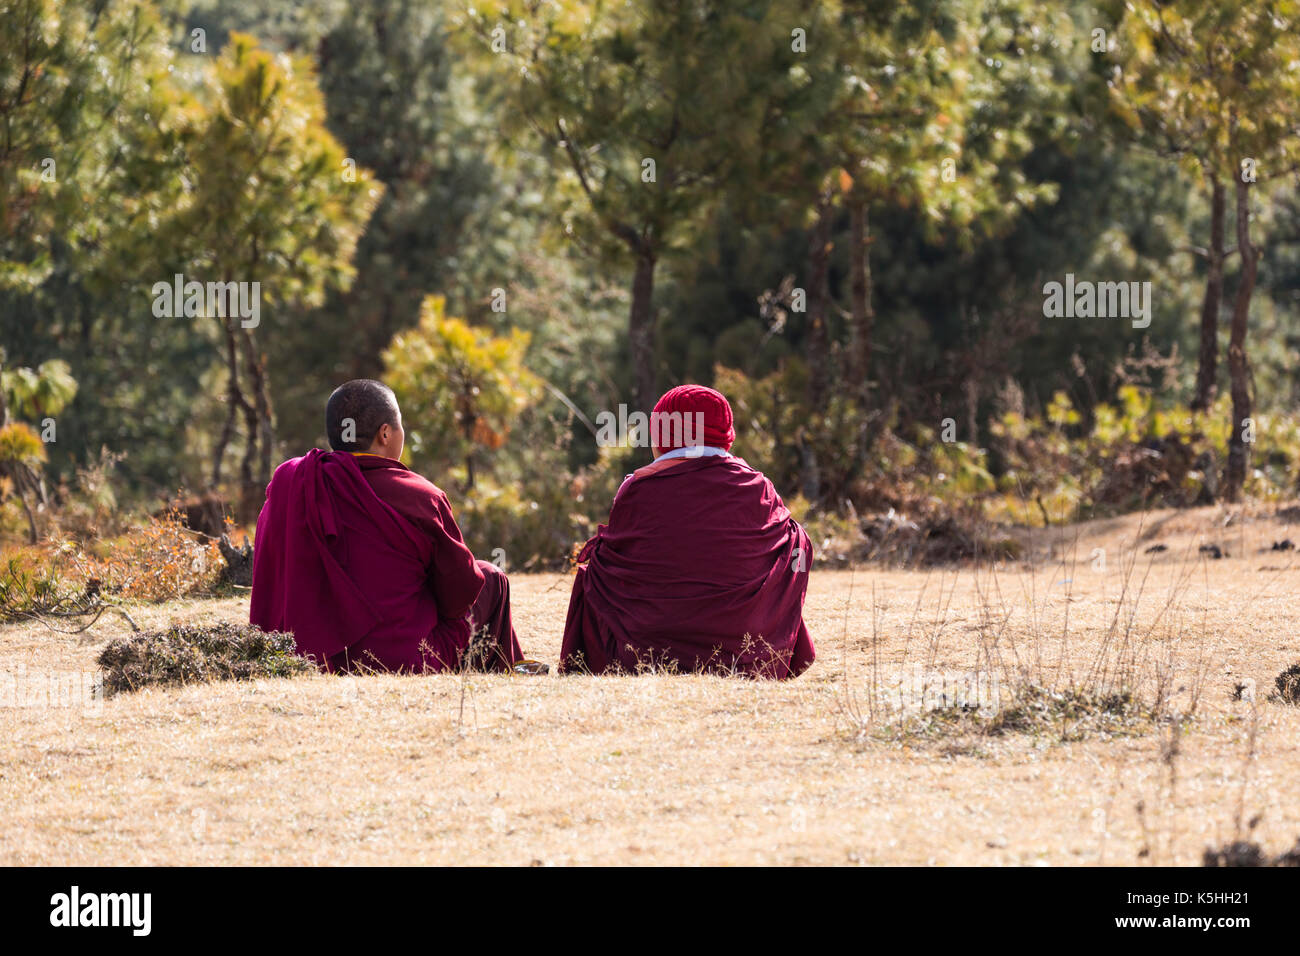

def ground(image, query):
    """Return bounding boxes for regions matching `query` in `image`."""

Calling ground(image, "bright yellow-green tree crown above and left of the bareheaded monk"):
[161,34,382,306]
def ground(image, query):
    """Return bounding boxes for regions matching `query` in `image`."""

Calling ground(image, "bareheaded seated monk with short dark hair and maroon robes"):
[248,378,540,672]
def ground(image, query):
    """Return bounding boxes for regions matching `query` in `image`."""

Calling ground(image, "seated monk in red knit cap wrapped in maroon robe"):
[560,385,814,678]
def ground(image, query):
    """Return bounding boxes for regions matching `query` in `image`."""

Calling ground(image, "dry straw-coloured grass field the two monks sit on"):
[0,509,1300,865]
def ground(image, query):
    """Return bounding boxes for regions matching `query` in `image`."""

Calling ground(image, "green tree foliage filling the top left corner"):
[0,0,176,294]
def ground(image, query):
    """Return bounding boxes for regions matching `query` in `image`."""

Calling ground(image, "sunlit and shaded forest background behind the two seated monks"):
[0,0,1300,567]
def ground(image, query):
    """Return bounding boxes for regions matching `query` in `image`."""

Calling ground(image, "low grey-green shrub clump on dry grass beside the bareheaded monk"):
[99,623,316,695]
